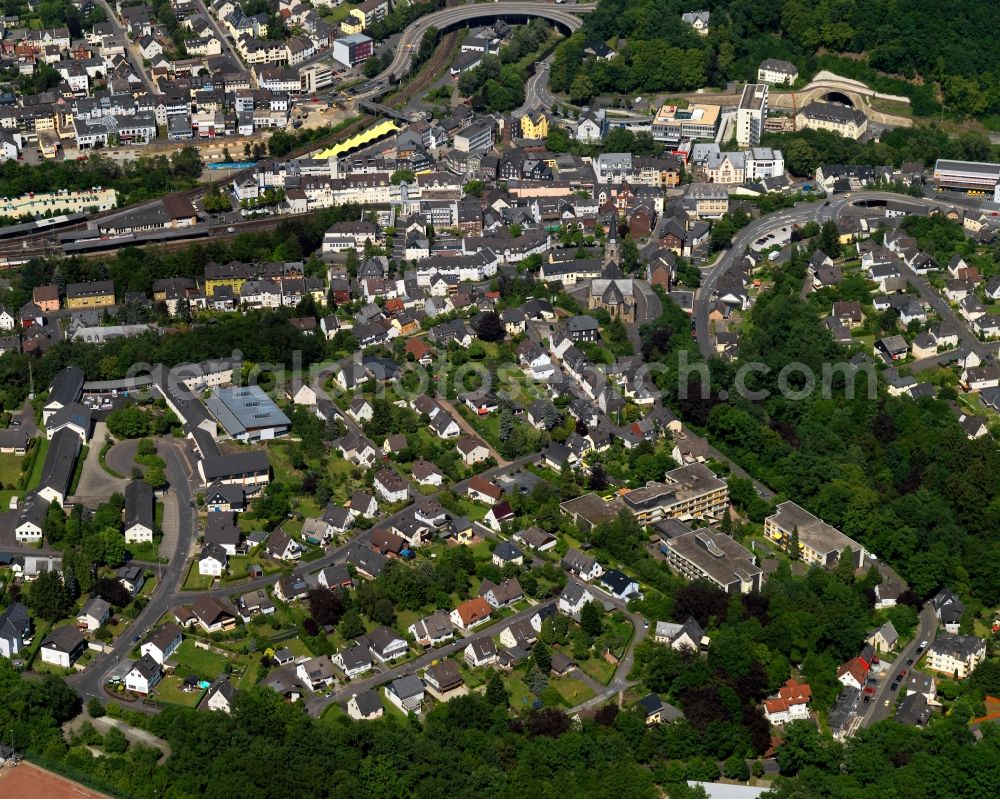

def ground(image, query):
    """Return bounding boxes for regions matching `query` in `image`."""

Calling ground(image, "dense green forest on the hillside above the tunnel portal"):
[551,0,1000,116]
